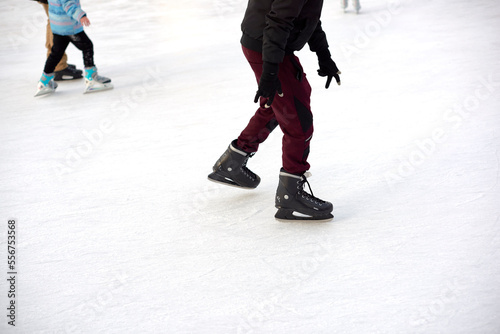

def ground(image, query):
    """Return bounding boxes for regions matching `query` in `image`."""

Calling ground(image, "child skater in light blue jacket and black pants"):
[35,0,113,96]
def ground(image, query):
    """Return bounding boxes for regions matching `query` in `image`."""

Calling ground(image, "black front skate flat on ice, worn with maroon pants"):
[274,168,333,220]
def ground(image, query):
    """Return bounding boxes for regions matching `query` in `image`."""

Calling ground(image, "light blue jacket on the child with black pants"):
[49,0,86,36]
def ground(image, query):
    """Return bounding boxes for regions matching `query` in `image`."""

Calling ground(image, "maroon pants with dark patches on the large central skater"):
[237,47,313,174]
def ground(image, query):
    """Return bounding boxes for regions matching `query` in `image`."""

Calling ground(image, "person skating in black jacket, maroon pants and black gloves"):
[208,0,340,220]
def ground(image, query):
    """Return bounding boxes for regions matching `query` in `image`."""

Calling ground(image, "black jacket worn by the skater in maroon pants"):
[241,0,328,63]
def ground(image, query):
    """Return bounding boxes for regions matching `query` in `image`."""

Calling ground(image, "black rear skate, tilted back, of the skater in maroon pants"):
[208,140,260,189]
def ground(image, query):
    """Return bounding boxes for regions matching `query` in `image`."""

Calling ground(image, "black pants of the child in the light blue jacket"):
[43,31,94,73]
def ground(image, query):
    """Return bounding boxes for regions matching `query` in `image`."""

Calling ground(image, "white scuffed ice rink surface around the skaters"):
[0,0,500,334]
